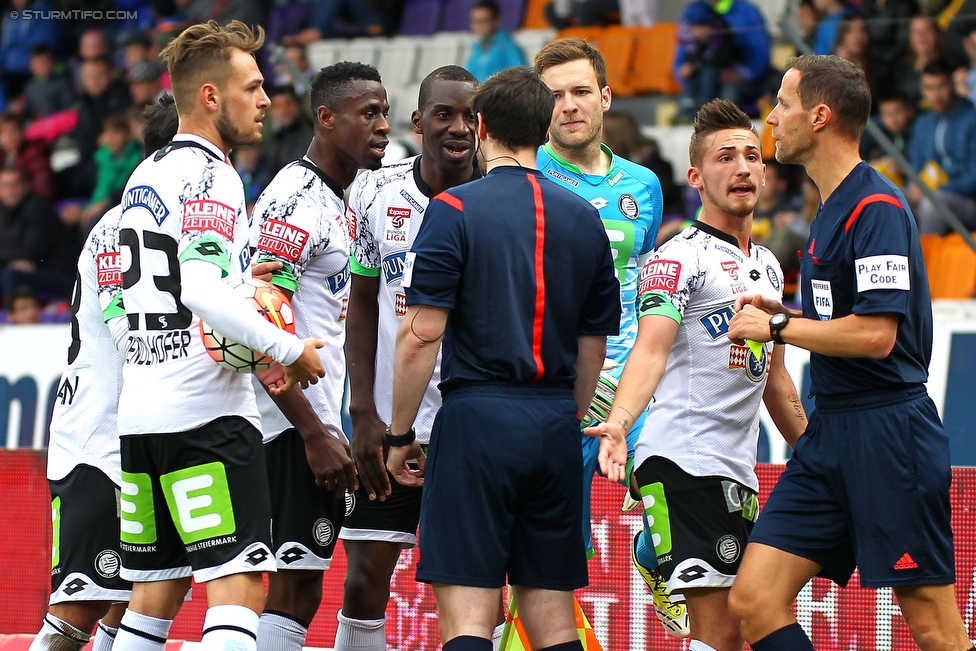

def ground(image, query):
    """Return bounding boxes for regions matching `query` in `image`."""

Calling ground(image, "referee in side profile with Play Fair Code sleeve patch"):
[728,55,972,651]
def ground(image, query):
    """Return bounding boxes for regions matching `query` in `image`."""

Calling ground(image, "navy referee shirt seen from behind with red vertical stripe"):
[403,166,621,391]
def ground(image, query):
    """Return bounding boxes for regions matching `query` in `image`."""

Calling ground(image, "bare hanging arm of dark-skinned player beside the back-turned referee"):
[346,273,392,500]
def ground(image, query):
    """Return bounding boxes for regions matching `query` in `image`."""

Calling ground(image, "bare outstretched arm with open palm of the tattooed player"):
[583,314,678,483]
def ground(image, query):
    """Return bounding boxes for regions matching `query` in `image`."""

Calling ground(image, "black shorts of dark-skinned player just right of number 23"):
[264,429,346,570]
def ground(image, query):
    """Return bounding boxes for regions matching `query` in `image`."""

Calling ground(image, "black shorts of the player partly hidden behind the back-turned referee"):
[339,445,427,549]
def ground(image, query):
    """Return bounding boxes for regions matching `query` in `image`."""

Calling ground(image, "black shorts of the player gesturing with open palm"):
[634,457,759,593]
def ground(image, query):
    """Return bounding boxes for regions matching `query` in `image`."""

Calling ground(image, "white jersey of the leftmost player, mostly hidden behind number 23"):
[47,206,125,485]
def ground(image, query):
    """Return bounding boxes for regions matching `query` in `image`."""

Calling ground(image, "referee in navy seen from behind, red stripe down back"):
[387,68,626,651]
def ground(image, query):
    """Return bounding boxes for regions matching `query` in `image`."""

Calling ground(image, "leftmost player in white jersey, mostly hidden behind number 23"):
[30,95,178,651]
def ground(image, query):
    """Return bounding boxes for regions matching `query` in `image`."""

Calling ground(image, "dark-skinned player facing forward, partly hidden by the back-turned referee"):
[335,66,477,651]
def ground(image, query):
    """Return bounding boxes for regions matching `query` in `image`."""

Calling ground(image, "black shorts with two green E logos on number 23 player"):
[120,416,275,583]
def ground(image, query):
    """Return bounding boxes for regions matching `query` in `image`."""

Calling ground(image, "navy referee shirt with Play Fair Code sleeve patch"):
[800,162,932,396]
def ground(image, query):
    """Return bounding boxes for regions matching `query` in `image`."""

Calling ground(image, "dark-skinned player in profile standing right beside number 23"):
[253,62,390,651]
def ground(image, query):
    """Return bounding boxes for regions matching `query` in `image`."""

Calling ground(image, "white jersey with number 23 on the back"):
[119,134,260,435]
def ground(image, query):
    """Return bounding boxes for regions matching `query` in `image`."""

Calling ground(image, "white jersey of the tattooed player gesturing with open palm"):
[635,222,783,490]
